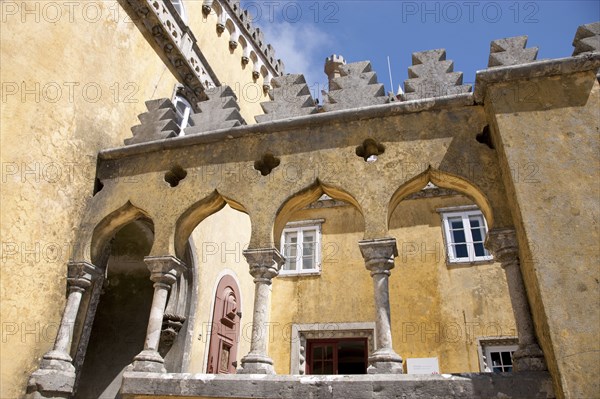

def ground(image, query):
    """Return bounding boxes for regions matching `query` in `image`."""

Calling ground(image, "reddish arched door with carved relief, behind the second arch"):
[206,275,242,374]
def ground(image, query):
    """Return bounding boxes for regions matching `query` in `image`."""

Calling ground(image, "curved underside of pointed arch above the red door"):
[175,190,248,257]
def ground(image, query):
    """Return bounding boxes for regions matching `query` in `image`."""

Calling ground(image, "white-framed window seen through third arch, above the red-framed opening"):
[280,219,324,275]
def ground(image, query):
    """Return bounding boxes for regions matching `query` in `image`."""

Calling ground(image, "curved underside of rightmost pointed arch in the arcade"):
[388,166,494,229]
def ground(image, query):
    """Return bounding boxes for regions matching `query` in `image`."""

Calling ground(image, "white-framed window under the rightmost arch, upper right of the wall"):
[438,206,493,263]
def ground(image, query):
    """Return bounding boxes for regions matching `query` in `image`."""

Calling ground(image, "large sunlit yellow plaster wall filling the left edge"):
[0,1,176,398]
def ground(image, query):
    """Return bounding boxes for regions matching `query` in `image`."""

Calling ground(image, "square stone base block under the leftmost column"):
[26,365,76,399]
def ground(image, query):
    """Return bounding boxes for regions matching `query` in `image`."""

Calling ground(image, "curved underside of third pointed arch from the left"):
[273,179,364,248]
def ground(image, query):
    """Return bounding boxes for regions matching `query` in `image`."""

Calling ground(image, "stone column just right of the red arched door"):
[238,248,285,374]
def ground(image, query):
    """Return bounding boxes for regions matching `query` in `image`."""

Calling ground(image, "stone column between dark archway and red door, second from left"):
[129,255,185,373]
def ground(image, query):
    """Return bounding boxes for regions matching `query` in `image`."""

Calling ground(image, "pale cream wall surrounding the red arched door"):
[188,206,254,373]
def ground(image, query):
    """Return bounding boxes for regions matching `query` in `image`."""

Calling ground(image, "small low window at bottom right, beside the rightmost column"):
[478,337,519,373]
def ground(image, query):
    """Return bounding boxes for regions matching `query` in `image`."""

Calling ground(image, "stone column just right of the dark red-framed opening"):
[358,238,402,374]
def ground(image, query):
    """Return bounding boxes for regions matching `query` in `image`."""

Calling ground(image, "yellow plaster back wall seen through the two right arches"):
[269,196,516,374]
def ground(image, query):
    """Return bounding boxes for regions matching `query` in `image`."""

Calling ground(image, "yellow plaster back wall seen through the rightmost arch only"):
[390,196,516,373]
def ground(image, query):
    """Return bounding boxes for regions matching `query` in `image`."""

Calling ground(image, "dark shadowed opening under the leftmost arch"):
[75,219,154,398]
